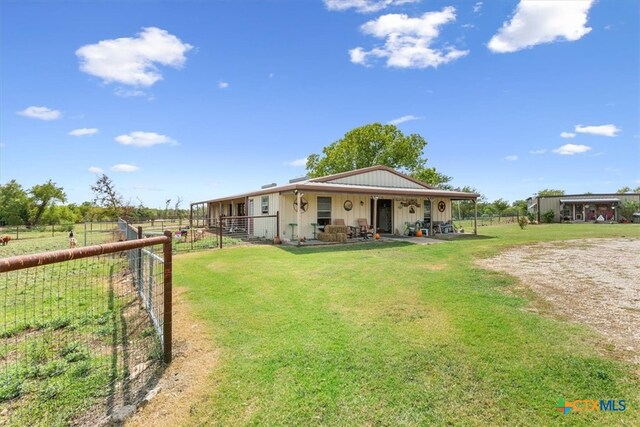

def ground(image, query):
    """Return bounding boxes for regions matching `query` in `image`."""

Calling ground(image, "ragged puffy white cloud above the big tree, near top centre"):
[349,6,469,68]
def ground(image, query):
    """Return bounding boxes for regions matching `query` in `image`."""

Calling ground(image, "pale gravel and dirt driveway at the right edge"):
[479,238,640,364]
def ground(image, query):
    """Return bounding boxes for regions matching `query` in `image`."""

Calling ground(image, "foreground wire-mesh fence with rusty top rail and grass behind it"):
[0,233,172,426]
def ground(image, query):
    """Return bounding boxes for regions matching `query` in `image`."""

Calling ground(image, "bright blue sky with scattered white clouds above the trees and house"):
[0,0,640,207]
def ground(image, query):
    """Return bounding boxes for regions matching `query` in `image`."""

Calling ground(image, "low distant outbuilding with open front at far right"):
[527,193,640,222]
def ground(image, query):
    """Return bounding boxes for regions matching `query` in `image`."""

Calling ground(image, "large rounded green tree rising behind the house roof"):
[307,123,451,185]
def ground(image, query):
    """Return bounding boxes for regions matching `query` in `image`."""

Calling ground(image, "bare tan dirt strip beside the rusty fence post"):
[126,288,218,426]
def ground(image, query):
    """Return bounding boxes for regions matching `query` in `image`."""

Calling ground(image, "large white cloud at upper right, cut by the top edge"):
[488,0,593,53]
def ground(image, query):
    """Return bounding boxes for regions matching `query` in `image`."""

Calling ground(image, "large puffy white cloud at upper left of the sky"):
[76,27,193,87]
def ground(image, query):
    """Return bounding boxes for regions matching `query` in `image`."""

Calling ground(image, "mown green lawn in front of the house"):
[174,224,640,426]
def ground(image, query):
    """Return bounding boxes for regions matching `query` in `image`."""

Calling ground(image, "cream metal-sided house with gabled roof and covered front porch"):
[191,166,479,240]
